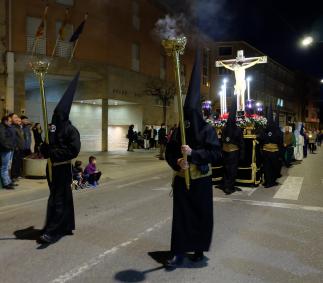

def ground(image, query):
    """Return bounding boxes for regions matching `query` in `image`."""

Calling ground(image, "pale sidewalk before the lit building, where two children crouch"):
[0,150,169,207]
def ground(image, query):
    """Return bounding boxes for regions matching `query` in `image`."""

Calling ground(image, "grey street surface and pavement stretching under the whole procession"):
[0,148,323,283]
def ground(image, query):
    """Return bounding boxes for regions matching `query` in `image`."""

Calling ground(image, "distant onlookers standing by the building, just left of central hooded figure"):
[127,123,177,160]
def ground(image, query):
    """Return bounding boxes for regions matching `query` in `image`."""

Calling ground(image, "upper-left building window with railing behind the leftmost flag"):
[26,17,46,55]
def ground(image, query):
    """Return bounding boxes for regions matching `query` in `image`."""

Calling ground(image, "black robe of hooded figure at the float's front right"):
[258,127,283,186]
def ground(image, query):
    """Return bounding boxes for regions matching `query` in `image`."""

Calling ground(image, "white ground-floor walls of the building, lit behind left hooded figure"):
[26,85,143,151]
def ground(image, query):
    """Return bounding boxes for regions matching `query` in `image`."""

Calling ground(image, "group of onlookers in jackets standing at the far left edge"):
[0,113,42,190]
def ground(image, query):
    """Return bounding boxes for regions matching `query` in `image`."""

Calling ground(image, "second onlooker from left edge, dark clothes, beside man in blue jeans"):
[9,113,25,180]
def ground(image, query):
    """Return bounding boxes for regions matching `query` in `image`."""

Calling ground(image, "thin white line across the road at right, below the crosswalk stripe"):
[213,197,323,212]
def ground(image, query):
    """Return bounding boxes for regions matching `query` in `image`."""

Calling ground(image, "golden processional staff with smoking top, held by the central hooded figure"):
[162,36,190,190]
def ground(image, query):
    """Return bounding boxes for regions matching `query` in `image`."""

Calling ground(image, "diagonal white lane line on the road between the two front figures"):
[51,217,170,283]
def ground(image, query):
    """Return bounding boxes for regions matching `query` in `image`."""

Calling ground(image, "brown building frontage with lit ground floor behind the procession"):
[0,0,320,151]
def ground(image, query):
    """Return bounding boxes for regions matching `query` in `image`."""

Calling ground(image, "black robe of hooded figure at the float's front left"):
[222,125,244,193]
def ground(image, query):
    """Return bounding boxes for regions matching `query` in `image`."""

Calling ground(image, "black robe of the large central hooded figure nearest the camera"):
[166,125,220,254]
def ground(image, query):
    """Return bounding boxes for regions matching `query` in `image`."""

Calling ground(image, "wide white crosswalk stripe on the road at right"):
[274,176,304,200]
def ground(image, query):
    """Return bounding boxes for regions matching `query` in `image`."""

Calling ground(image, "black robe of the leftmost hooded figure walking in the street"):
[41,122,81,236]
